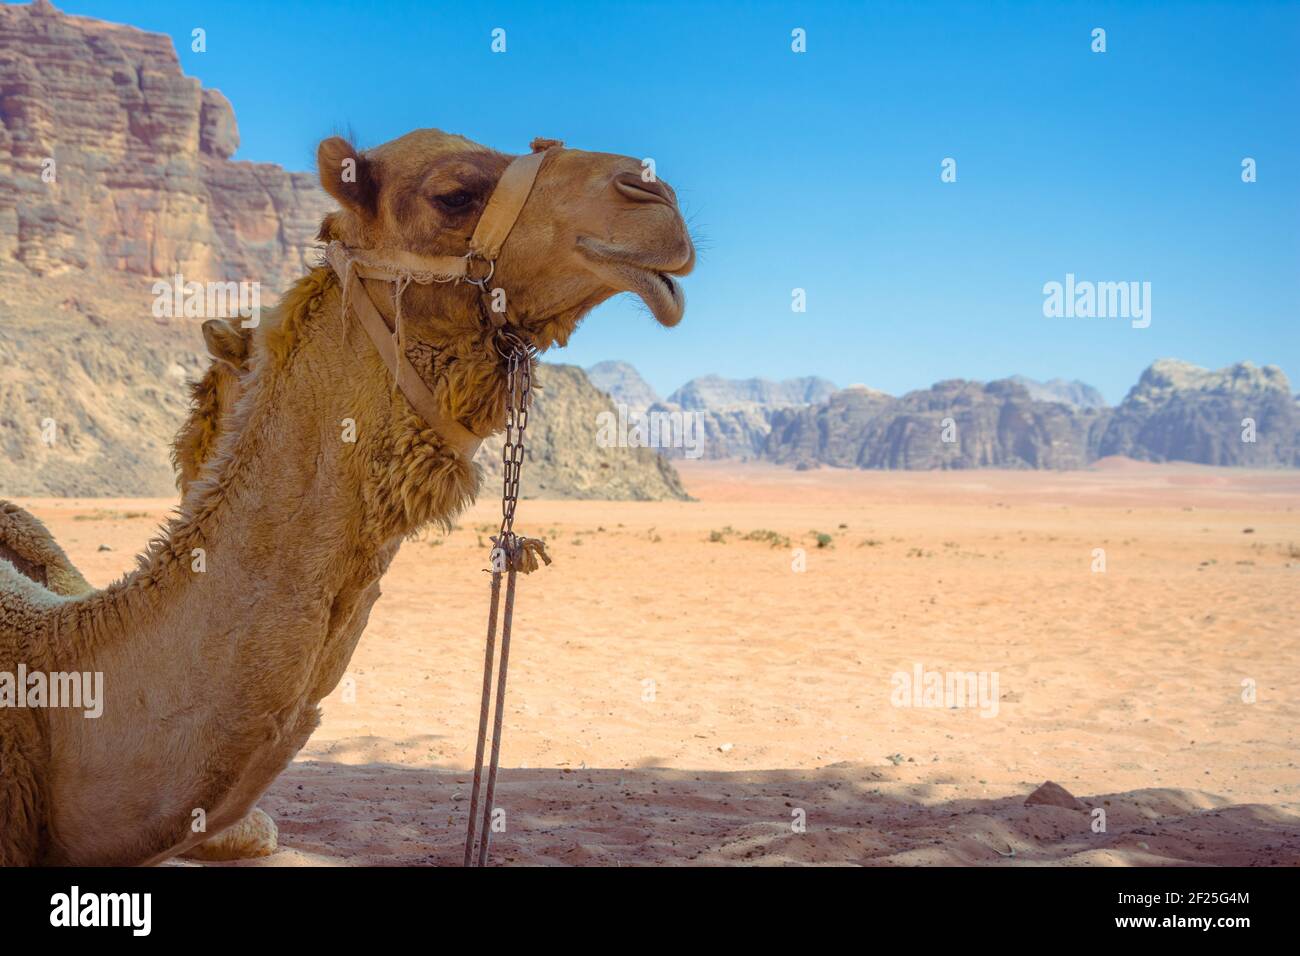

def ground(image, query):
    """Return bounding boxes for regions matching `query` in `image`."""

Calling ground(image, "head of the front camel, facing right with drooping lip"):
[317,129,696,349]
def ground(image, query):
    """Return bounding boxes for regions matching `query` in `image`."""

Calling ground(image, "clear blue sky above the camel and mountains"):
[35,0,1300,402]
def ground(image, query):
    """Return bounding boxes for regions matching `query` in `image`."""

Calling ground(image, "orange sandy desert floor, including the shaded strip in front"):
[12,462,1300,866]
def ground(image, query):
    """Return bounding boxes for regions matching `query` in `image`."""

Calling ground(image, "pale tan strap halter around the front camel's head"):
[325,139,564,460]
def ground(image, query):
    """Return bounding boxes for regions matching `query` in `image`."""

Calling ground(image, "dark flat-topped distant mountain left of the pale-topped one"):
[764,378,1105,470]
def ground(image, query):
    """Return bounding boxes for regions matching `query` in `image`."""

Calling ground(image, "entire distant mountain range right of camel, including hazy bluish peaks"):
[589,359,1300,470]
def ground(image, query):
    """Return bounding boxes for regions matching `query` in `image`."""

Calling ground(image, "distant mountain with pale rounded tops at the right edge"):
[1100,359,1300,467]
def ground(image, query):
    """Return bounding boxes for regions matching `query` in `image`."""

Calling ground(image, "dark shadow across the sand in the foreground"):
[195,760,1300,866]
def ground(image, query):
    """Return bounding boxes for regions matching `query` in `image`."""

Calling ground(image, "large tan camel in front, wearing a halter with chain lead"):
[0,130,694,865]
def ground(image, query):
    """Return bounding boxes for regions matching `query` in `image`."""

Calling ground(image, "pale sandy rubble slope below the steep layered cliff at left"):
[0,267,207,497]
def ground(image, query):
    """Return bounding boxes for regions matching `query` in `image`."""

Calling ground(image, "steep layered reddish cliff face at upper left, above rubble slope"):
[0,0,329,291]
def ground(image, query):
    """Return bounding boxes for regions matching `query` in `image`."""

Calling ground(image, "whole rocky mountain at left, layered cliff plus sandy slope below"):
[0,1,329,496]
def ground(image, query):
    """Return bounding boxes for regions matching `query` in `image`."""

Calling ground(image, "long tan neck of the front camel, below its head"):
[39,278,475,864]
